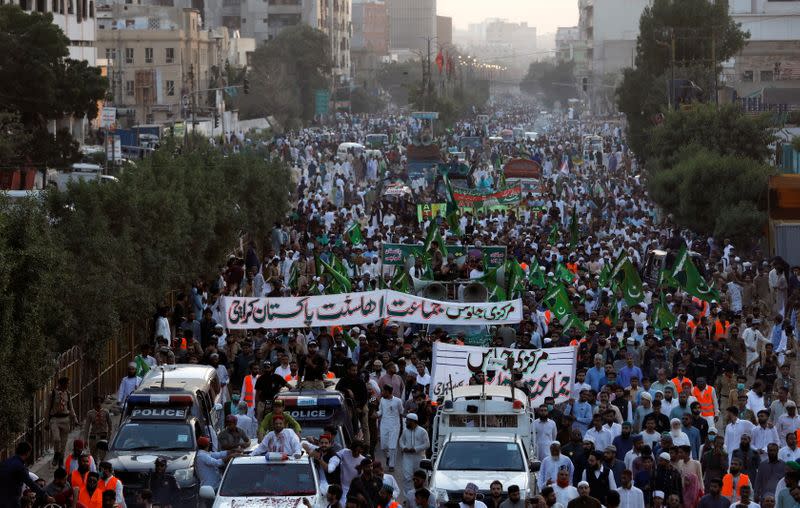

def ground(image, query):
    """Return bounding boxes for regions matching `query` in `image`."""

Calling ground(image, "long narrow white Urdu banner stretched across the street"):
[223,290,522,329]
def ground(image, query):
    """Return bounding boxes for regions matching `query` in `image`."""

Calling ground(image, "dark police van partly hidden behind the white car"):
[275,390,355,448]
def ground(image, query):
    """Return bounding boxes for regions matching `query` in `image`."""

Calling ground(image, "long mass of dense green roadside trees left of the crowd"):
[40,146,291,347]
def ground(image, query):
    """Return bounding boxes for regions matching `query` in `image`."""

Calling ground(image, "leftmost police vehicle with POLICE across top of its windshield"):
[106,390,206,506]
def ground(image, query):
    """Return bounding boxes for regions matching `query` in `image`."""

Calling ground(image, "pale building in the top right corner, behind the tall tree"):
[723,0,800,109]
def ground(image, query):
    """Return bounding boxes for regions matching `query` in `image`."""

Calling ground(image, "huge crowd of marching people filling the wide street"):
[3,100,800,508]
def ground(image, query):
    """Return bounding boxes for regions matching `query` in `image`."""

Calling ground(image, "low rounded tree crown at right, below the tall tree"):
[650,146,774,245]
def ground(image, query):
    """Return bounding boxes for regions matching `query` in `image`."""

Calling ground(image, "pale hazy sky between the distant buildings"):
[436,0,578,34]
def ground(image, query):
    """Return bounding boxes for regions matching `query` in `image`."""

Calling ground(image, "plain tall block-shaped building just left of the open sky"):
[386,0,436,52]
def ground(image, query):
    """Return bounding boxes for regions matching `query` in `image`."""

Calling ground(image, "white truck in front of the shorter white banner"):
[420,385,541,506]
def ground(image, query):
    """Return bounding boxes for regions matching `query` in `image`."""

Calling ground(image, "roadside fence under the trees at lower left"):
[0,323,141,460]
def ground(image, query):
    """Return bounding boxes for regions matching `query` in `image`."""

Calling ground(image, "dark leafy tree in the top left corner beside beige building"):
[0,4,107,167]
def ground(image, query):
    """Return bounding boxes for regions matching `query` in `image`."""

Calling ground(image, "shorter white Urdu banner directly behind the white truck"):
[431,342,578,407]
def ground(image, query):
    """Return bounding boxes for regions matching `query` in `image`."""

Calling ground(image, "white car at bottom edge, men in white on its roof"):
[200,453,327,508]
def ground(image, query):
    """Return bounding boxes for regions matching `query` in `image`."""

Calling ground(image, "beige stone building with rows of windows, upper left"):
[97,4,229,127]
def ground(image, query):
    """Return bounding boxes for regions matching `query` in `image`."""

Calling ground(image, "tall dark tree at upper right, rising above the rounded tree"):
[617,0,749,154]
